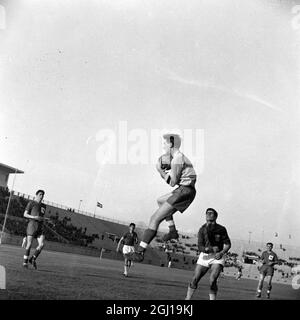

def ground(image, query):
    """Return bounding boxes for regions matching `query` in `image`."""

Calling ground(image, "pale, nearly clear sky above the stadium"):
[0,0,300,245]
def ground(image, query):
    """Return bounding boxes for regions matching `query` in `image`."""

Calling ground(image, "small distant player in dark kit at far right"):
[256,242,278,299]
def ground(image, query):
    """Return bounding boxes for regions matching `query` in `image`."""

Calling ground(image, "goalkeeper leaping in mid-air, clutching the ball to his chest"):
[127,134,196,262]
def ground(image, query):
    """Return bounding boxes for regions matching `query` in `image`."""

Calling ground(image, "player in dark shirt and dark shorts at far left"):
[23,190,46,269]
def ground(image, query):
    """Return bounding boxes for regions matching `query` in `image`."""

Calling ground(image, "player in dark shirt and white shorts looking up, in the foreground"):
[185,208,231,300]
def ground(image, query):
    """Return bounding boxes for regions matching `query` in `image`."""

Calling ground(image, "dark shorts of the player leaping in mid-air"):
[167,186,196,213]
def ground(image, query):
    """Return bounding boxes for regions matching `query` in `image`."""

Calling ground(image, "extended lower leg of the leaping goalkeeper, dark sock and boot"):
[127,202,177,262]
